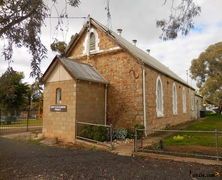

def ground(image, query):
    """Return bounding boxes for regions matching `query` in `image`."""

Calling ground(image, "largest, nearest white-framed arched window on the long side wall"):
[156,77,163,117]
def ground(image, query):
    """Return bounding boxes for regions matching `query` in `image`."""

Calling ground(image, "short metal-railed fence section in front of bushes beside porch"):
[76,122,113,149]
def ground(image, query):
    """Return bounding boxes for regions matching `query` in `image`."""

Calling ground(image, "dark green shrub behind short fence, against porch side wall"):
[79,125,109,142]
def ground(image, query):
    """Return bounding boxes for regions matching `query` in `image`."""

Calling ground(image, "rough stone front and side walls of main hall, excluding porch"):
[66,22,194,128]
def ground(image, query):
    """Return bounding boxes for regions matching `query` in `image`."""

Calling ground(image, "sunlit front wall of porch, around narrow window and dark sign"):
[43,80,76,142]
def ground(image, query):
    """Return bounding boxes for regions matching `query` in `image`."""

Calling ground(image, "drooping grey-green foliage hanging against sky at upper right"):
[156,0,201,40]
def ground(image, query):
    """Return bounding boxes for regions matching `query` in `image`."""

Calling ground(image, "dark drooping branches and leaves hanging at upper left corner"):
[0,0,80,79]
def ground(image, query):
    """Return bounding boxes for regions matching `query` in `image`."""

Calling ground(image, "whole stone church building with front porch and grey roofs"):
[42,18,200,142]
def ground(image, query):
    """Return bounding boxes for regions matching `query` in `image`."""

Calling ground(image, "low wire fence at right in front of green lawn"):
[134,129,222,160]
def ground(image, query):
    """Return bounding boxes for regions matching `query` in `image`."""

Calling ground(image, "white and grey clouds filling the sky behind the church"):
[0,0,222,85]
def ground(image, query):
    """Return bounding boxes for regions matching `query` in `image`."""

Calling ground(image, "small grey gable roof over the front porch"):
[42,56,108,84]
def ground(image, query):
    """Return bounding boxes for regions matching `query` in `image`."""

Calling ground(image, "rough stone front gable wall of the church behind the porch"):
[70,24,143,128]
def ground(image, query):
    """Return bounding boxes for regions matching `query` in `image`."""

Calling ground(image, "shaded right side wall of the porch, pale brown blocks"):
[76,81,105,124]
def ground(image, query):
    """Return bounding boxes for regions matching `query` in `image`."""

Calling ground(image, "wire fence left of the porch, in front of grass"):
[0,116,42,135]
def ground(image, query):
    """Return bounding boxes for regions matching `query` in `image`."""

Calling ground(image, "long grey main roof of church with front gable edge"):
[66,18,194,89]
